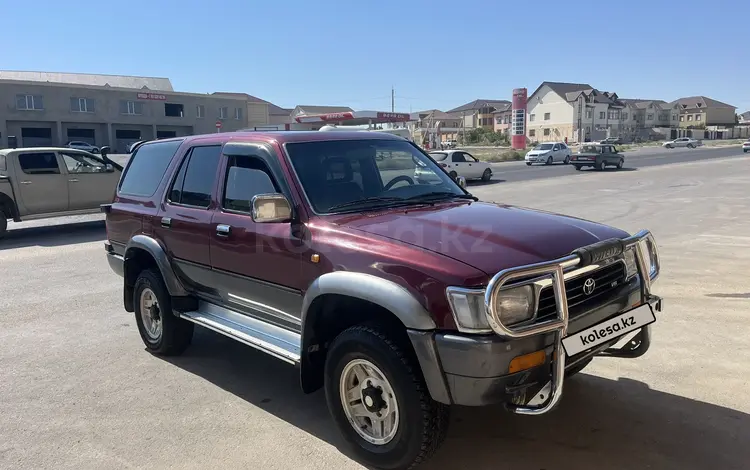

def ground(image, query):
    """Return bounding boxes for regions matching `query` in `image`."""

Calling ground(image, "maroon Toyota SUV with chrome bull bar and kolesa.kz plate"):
[103,131,662,469]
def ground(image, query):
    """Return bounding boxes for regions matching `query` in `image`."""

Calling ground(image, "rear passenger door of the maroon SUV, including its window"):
[153,145,221,294]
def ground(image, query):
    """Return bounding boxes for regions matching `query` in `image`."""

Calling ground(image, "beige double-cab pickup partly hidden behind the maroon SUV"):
[0,147,122,236]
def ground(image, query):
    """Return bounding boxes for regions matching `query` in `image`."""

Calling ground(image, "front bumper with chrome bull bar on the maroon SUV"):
[409,231,662,415]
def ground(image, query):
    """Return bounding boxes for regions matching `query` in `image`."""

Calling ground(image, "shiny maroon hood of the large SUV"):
[329,202,629,276]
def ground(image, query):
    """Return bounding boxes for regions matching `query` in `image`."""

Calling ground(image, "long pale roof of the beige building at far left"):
[0,70,174,91]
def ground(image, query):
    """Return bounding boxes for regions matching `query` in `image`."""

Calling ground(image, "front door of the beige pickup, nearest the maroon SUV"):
[59,151,120,210]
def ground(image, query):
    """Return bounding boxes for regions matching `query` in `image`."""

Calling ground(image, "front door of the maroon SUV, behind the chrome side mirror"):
[211,147,314,331]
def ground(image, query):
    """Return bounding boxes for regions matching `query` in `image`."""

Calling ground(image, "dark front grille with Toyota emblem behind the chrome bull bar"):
[537,261,625,320]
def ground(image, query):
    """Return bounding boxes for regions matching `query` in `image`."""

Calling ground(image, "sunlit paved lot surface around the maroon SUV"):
[0,157,750,470]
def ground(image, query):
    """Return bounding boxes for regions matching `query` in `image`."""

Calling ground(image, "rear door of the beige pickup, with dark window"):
[16,152,68,216]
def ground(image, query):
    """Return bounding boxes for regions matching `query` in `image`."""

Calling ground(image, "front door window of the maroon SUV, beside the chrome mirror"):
[222,155,280,213]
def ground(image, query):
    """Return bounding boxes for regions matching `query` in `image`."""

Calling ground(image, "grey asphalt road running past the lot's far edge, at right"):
[484,146,743,184]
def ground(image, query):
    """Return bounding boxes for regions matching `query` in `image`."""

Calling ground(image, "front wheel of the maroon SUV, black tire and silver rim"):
[324,325,448,470]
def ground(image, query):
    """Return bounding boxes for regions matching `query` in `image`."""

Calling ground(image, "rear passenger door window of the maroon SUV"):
[170,145,221,207]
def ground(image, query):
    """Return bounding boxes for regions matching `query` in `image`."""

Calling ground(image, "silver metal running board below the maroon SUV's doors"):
[180,301,302,365]
